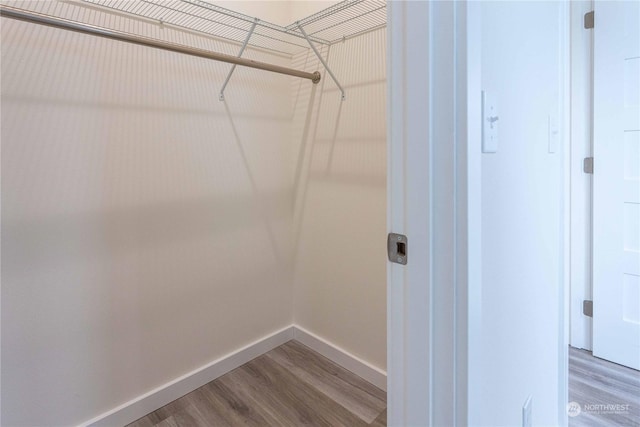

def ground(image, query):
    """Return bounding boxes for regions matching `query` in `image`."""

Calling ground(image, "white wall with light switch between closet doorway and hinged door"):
[469,2,564,426]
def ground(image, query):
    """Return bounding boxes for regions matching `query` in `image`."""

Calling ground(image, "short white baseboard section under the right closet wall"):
[293,325,387,391]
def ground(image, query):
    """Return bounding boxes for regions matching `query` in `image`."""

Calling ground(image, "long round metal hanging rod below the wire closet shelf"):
[0,5,320,84]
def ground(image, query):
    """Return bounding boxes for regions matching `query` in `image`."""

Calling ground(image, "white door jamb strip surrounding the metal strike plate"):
[387,1,435,426]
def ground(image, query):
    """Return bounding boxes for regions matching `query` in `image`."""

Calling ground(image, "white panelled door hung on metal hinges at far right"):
[593,1,640,369]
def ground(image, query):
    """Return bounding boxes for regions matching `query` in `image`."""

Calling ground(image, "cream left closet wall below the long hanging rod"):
[0,1,293,426]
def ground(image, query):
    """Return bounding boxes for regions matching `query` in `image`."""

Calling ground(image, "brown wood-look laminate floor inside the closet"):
[129,341,387,427]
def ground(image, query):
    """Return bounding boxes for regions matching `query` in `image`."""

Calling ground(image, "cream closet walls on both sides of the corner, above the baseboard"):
[0,1,386,426]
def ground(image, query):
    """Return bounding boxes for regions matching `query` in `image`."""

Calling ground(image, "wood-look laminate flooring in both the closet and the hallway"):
[128,341,640,427]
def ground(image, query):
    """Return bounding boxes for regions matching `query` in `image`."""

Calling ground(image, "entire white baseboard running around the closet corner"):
[79,325,387,427]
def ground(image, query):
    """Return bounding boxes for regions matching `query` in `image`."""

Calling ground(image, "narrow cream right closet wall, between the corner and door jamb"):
[293,29,387,371]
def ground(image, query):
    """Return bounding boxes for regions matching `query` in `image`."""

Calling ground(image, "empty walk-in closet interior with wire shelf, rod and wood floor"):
[0,0,387,427]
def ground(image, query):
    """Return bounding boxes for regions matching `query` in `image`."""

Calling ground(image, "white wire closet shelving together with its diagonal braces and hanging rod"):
[0,0,386,96]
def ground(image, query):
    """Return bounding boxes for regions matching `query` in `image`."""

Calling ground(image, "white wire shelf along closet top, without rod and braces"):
[0,0,386,55]
